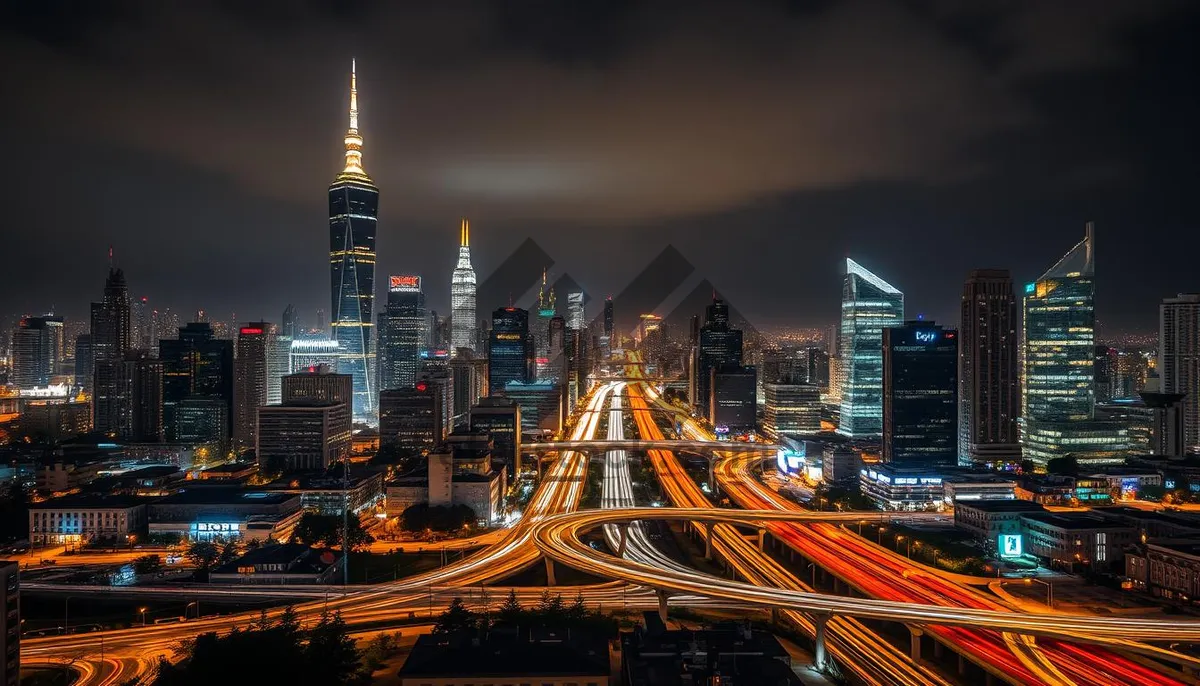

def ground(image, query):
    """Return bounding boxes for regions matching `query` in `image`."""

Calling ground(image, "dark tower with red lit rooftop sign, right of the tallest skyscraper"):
[377,275,428,390]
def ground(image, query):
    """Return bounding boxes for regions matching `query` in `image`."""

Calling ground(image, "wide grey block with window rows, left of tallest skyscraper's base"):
[256,402,350,471]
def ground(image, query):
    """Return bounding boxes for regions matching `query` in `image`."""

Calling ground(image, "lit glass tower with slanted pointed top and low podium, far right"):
[1020,223,1128,467]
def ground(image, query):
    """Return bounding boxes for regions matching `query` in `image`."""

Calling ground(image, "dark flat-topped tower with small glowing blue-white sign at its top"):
[883,321,959,467]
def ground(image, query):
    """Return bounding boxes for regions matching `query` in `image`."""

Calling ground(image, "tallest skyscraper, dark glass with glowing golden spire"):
[329,62,379,422]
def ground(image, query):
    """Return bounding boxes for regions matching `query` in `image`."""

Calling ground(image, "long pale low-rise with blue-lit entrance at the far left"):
[29,494,146,547]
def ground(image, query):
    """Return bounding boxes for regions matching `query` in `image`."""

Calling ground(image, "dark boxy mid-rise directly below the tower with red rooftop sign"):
[379,380,449,455]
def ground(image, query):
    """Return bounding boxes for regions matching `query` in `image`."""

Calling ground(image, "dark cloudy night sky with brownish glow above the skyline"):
[0,0,1200,333]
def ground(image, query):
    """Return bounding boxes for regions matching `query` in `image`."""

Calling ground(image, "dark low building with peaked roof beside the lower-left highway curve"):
[209,543,342,584]
